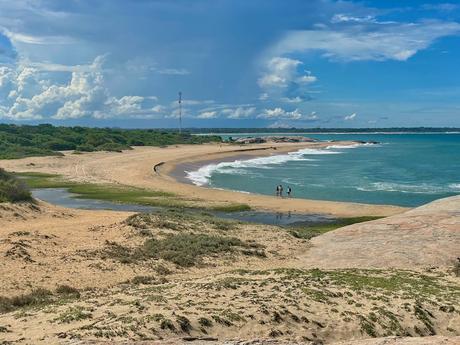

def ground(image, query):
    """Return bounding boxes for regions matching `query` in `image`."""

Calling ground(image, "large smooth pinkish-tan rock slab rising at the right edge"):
[304,196,460,269]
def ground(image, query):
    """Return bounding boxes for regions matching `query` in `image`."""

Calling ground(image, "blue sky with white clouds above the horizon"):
[0,0,460,128]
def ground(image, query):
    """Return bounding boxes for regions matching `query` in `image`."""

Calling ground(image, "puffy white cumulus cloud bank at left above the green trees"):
[0,56,158,120]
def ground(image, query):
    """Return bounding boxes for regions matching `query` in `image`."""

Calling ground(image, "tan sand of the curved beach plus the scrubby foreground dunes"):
[0,144,460,345]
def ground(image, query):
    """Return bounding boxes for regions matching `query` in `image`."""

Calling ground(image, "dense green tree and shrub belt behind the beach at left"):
[0,124,221,159]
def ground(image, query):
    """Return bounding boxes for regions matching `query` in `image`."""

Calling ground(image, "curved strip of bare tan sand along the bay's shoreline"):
[0,142,407,217]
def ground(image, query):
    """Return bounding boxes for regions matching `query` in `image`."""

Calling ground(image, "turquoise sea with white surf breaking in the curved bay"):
[187,134,460,206]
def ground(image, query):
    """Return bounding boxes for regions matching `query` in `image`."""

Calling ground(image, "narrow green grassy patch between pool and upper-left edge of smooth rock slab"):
[289,216,382,240]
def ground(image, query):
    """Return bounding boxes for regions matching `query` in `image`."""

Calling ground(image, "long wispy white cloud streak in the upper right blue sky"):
[269,20,460,61]
